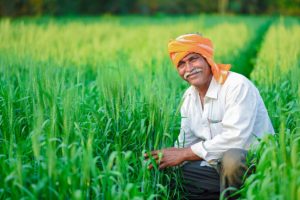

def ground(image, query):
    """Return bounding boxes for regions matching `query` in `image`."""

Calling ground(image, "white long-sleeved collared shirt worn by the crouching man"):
[175,72,274,166]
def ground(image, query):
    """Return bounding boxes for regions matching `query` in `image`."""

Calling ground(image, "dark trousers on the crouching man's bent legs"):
[181,149,248,200]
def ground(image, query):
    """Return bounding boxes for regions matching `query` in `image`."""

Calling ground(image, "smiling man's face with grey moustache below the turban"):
[177,53,212,87]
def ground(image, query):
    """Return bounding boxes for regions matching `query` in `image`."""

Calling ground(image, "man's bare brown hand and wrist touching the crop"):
[144,147,201,169]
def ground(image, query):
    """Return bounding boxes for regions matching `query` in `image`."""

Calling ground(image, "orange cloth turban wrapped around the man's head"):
[168,34,231,84]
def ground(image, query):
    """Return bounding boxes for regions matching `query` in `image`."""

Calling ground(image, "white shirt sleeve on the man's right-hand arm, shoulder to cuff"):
[191,83,257,162]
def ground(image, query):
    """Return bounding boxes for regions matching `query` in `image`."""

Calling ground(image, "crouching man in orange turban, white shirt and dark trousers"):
[145,34,274,199]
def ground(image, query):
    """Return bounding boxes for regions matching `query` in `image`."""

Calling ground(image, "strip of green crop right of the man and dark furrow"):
[239,18,300,199]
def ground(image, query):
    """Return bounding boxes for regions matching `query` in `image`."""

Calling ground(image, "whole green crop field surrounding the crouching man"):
[0,15,300,200]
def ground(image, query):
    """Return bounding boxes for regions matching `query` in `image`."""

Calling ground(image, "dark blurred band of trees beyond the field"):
[0,0,300,17]
